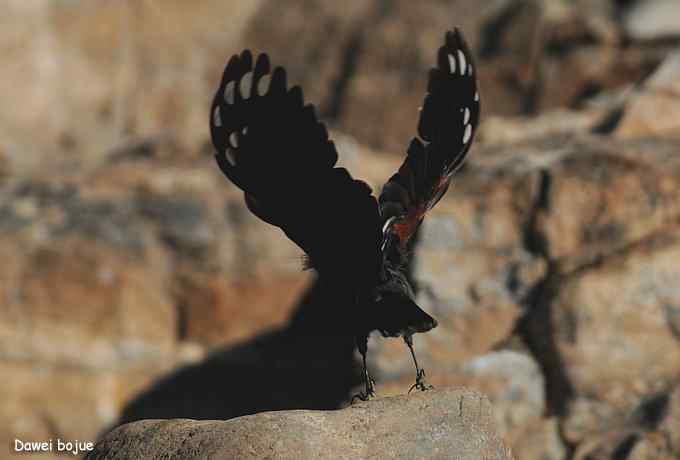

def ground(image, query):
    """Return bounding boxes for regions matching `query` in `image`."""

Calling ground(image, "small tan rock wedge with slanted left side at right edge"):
[615,51,680,138]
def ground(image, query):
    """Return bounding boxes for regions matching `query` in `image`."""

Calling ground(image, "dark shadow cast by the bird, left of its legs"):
[114,281,361,431]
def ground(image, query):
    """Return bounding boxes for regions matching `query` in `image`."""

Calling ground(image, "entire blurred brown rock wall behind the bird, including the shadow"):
[0,0,680,459]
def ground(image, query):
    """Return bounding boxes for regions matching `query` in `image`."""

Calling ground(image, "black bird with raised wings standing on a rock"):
[209,28,480,400]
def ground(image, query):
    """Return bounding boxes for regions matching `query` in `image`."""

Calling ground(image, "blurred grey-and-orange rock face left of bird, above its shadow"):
[0,157,310,450]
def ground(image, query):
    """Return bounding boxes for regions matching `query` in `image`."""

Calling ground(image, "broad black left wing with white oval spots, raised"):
[210,50,382,285]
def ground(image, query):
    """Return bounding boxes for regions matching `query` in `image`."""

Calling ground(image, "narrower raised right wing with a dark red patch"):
[380,29,480,253]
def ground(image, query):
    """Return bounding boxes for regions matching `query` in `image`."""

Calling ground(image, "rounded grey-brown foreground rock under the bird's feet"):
[91,390,512,460]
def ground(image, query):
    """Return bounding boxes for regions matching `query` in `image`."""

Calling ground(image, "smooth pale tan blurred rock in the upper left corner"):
[0,0,261,172]
